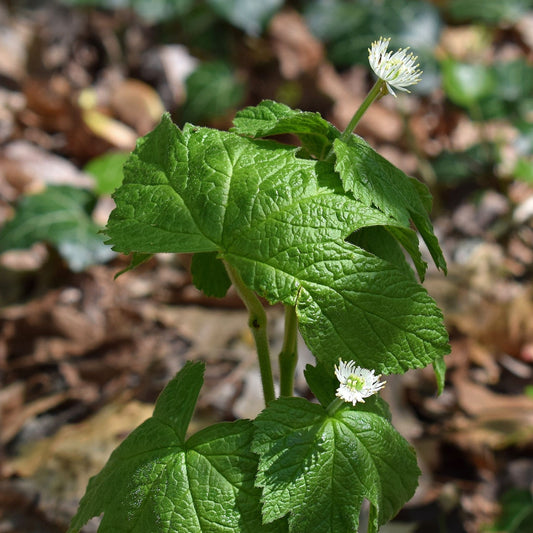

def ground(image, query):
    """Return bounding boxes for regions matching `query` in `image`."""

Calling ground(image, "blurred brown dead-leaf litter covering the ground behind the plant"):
[0,4,533,533]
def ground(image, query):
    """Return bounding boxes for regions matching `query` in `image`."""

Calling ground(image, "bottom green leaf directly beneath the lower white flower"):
[252,398,419,533]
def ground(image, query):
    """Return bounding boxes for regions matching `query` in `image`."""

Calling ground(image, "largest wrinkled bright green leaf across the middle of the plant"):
[107,117,448,373]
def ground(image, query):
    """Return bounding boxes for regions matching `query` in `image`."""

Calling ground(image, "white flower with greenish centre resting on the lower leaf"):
[335,359,386,405]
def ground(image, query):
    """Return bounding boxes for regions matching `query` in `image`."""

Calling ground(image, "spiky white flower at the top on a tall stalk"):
[368,37,422,96]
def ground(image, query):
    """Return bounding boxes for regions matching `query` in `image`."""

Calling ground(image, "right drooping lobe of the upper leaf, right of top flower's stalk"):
[334,135,446,272]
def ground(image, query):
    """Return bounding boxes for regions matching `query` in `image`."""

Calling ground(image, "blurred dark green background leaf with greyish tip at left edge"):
[0,185,113,271]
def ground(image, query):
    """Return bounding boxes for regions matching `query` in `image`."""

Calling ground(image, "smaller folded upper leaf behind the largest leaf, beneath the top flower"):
[233,100,436,279]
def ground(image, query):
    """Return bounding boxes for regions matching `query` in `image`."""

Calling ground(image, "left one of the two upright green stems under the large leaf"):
[224,261,276,404]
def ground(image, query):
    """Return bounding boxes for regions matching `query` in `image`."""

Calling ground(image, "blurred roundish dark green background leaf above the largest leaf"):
[183,61,244,122]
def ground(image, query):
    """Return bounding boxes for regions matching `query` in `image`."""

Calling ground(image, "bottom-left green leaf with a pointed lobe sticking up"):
[69,363,286,533]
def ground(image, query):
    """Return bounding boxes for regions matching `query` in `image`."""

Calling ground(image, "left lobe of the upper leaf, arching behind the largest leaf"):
[232,100,340,159]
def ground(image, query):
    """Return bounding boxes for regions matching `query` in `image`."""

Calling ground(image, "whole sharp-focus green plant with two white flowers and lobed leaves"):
[69,39,449,533]
